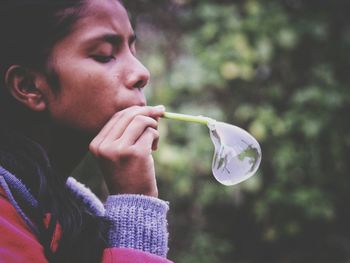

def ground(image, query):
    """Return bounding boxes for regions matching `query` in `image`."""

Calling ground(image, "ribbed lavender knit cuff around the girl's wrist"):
[105,195,169,257]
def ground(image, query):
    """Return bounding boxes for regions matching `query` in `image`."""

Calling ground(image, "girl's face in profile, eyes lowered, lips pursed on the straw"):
[44,0,149,133]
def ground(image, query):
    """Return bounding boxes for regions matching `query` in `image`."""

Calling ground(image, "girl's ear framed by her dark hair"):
[5,65,47,111]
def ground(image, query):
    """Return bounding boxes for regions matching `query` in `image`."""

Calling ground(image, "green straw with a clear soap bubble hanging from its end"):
[163,112,261,185]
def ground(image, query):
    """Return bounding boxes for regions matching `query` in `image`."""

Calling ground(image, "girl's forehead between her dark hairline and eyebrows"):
[73,0,133,38]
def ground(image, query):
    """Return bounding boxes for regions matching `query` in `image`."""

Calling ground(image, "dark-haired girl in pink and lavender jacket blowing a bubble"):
[0,0,169,263]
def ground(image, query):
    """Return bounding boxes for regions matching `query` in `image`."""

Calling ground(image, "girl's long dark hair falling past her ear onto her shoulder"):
[0,0,109,263]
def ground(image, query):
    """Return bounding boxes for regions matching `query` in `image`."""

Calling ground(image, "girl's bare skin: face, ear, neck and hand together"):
[7,0,164,197]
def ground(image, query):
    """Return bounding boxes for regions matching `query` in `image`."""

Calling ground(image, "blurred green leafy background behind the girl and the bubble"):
[77,0,350,263]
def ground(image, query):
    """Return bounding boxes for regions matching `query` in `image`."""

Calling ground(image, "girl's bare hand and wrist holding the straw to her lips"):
[89,106,164,197]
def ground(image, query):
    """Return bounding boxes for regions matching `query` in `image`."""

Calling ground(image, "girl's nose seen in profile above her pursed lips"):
[126,56,150,89]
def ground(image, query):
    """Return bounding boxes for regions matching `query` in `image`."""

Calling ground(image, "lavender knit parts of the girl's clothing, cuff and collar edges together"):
[0,166,169,257]
